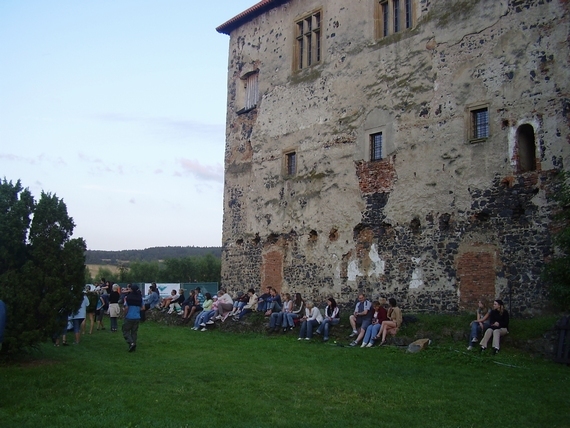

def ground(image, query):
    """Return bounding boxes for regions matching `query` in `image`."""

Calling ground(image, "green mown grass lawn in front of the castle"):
[0,321,570,428]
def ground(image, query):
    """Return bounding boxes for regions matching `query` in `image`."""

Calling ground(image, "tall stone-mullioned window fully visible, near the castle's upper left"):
[295,11,322,70]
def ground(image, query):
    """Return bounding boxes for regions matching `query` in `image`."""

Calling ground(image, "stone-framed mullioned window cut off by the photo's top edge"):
[374,0,417,39]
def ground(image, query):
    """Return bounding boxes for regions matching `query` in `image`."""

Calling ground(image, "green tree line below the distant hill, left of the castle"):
[85,253,222,284]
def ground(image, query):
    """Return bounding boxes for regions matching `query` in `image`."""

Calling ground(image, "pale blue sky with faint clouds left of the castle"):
[0,0,257,250]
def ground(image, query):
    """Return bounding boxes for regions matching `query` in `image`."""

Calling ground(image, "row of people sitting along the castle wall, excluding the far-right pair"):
[149,287,402,348]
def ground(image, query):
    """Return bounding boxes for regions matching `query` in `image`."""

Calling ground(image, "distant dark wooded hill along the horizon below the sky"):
[85,247,222,265]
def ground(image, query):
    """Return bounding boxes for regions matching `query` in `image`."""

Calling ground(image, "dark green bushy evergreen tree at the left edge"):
[0,179,86,352]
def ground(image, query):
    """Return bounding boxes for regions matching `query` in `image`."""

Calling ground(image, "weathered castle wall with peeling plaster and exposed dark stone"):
[218,0,570,313]
